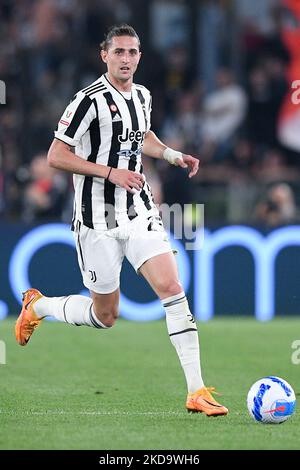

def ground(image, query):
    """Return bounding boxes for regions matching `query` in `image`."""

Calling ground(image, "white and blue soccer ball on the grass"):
[247,376,296,424]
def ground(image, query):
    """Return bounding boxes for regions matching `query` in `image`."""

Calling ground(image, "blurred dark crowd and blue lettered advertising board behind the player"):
[0,0,300,320]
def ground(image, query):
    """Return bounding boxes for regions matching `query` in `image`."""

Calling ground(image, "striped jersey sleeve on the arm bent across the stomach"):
[54,92,96,147]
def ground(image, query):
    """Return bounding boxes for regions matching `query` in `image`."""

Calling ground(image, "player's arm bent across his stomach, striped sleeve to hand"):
[48,92,144,193]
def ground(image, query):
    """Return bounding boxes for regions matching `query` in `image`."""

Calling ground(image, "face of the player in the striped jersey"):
[101,36,141,87]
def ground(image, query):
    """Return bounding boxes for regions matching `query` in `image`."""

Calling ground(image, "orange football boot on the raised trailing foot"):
[15,289,43,346]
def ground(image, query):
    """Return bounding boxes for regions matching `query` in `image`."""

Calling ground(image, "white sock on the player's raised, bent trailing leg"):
[34,295,108,328]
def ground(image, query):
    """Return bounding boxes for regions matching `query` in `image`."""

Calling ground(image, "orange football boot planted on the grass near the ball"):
[185,387,228,416]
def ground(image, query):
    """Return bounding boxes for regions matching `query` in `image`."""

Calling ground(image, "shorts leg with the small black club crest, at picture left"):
[74,225,124,294]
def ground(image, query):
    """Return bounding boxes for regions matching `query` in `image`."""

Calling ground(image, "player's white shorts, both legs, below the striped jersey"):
[74,216,172,294]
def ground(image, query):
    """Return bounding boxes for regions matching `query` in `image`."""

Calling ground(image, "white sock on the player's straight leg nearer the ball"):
[162,292,204,393]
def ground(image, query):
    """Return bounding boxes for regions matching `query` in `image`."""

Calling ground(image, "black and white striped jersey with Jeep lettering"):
[54,75,158,229]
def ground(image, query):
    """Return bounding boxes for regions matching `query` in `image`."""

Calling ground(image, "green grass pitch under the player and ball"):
[0,318,300,450]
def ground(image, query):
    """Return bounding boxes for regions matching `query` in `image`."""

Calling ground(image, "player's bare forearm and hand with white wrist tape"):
[143,131,199,178]
